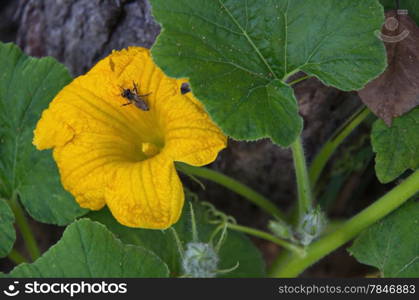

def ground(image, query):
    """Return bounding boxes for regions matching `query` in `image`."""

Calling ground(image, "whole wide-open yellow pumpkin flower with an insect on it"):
[33,47,226,229]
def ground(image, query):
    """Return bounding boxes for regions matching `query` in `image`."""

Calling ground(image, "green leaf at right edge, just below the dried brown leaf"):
[371,108,419,183]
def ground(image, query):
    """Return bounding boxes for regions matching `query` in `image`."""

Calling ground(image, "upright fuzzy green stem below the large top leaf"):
[291,137,312,219]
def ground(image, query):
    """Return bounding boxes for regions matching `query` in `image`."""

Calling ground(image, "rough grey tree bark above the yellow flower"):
[17,0,160,76]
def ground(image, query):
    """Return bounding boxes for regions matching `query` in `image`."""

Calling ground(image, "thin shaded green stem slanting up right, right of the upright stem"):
[309,106,370,187]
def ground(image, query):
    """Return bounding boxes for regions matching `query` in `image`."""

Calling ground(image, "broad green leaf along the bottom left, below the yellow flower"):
[9,219,169,278]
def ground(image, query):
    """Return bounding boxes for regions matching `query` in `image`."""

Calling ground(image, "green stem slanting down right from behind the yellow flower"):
[176,163,284,220]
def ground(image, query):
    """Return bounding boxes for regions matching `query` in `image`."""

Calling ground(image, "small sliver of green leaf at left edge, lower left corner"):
[0,198,16,257]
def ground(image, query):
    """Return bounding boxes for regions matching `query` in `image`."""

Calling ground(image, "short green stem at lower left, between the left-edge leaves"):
[10,194,41,261]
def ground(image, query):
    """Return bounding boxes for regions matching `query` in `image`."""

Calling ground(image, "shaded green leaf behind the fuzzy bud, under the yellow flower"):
[88,202,264,277]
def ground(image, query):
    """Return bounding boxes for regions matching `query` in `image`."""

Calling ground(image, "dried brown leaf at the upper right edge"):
[359,10,419,126]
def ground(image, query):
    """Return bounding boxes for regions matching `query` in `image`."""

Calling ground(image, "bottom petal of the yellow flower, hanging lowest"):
[106,155,184,229]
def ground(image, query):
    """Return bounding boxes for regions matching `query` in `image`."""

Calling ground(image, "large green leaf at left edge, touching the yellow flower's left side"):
[0,43,84,225]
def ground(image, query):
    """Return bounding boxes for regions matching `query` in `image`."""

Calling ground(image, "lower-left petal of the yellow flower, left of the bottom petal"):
[54,132,146,210]
